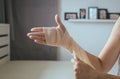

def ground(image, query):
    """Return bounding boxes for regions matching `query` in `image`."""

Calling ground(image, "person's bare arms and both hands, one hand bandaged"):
[27,15,120,79]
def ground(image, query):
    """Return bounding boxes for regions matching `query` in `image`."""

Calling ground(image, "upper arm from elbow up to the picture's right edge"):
[99,18,120,72]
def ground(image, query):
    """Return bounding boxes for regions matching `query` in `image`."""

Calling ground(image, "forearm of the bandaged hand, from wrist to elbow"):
[68,38,102,71]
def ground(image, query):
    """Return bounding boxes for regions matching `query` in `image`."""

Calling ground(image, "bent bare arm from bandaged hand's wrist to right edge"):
[71,18,120,72]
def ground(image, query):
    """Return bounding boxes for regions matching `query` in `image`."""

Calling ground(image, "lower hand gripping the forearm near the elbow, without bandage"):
[74,59,100,79]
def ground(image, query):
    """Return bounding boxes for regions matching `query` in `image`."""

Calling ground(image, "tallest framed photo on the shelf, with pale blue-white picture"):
[88,7,98,19]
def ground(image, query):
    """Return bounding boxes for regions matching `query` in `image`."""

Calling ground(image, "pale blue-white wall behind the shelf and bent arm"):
[58,0,120,74]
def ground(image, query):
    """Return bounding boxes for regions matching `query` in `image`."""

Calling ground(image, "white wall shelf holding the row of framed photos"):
[68,19,116,23]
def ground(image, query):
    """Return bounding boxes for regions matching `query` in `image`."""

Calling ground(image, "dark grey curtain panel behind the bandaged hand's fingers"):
[5,0,57,60]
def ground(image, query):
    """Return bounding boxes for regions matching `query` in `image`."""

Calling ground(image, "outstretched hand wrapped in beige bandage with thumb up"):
[27,15,71,49]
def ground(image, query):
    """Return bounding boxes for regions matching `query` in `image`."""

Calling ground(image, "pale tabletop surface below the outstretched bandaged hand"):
[0,61,74,79]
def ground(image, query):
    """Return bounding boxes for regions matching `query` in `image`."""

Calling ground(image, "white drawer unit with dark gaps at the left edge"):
[0,23,10,65]
